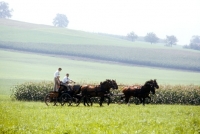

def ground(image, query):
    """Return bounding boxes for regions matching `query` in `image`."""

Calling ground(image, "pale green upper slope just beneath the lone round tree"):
[0,19,132,45]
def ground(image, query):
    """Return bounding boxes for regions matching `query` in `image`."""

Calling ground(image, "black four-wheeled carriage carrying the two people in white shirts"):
[44,85,81,106]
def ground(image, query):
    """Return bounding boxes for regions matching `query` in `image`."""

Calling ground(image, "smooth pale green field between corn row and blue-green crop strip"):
[0,50,200,94]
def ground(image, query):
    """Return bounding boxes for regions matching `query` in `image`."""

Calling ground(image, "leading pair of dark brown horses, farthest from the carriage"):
[121,80,159,105]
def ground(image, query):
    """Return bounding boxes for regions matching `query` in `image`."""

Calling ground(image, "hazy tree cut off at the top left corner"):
[0,1,13,18]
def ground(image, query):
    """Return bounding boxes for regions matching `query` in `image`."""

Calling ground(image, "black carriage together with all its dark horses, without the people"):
[45,79,159,106]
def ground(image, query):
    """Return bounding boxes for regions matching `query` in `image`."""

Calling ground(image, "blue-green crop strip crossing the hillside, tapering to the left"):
[0,43,200,71]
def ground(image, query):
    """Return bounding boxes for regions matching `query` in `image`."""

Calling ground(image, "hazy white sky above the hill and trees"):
[2,0,200,45]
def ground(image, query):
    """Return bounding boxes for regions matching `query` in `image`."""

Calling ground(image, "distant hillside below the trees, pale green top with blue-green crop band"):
[0,19,200,71]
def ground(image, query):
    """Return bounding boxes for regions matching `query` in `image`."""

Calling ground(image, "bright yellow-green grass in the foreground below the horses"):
[0,95,200,134]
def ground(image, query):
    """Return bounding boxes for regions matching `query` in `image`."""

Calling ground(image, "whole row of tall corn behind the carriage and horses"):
[11,81,200,105]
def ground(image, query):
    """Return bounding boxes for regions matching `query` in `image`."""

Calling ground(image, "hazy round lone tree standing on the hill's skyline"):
[53,14,69,27]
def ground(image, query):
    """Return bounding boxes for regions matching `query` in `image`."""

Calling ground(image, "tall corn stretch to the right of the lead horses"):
[152,85,200,105]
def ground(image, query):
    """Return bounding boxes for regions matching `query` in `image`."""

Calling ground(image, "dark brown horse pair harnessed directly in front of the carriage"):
[81,79,118,106]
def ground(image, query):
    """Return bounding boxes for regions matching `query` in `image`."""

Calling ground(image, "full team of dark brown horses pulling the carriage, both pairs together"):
[58,79,159,106]
